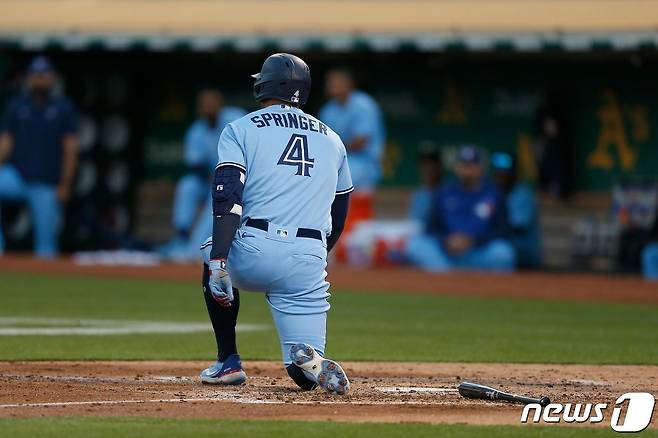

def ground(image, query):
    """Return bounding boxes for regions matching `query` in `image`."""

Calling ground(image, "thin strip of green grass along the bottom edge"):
[0,417,658,438]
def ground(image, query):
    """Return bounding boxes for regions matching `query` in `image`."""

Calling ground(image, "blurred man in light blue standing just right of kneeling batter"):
[319,69,386,260]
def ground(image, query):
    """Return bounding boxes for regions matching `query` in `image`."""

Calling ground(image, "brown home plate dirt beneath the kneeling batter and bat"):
[0,362,658,427]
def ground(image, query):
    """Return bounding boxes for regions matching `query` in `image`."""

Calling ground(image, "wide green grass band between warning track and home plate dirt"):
[0,272,658,364]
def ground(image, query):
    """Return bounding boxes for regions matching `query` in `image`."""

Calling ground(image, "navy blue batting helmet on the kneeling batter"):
[251,53,311,105]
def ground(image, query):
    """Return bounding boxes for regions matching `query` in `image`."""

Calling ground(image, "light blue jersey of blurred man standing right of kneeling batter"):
[320,91,386,190]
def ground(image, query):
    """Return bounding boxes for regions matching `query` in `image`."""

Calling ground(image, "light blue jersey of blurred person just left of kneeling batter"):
[183,106,246,170]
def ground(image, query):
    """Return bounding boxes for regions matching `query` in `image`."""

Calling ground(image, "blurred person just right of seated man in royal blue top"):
[490,152,541,269]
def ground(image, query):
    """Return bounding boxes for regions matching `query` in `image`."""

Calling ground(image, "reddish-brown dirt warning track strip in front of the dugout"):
[0,256,658,304]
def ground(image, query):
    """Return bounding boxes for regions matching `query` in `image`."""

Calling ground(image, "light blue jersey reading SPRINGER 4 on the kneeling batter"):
[218,105,352,235]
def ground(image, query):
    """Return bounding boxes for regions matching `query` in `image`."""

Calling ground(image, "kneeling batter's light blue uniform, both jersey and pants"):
[201,104,353,366]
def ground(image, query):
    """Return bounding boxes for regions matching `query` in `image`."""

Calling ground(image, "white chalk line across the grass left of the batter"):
[0,317,270,336]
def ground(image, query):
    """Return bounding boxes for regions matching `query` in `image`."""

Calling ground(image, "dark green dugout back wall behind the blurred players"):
[0,50,658,191]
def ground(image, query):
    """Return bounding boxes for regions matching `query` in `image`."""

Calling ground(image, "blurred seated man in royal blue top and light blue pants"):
[406,146,515,272]
